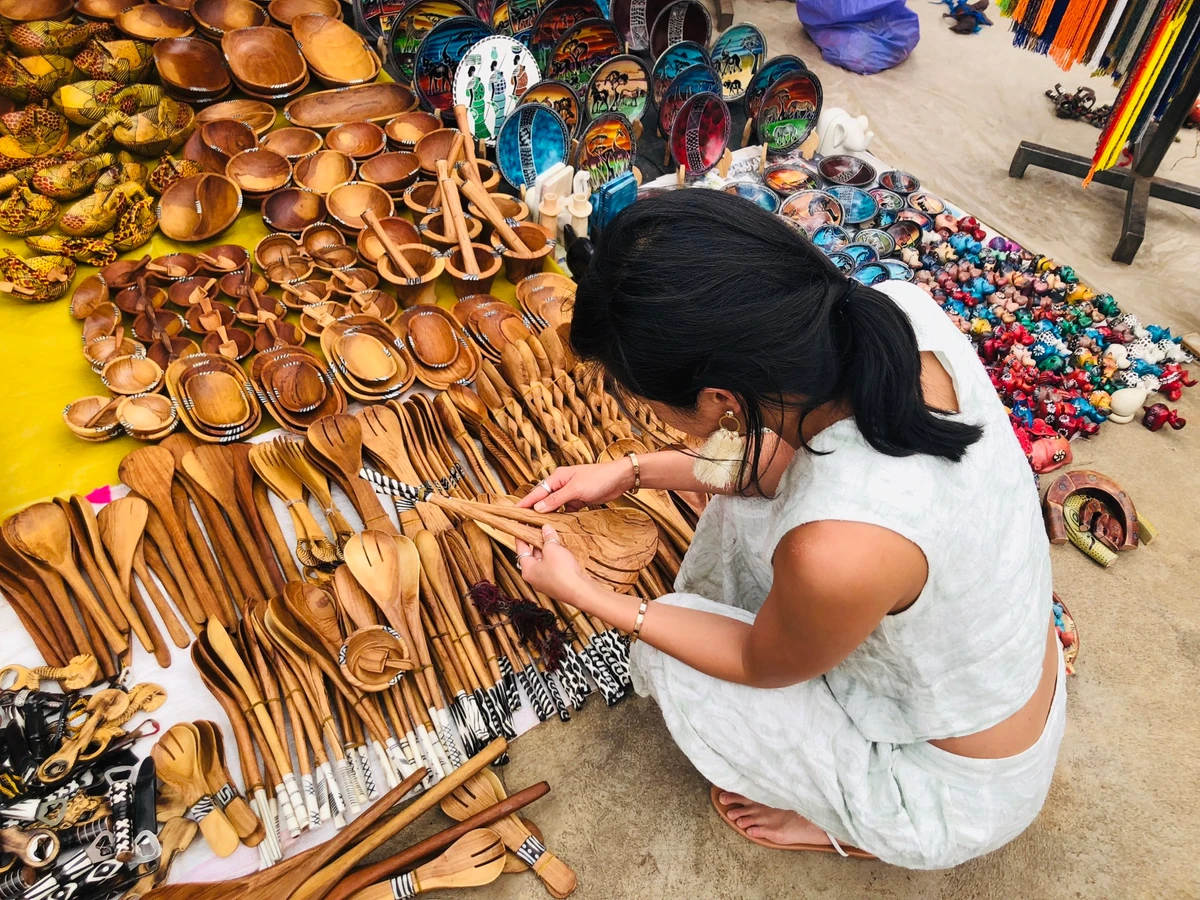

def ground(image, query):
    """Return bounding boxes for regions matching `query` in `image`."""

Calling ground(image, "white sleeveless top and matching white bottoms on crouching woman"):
[630,282,1066,869]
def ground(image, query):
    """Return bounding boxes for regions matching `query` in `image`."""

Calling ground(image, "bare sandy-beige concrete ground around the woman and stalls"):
[384,0,1200,900]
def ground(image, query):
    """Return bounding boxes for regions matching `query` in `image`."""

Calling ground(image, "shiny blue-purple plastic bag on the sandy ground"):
[796,0,920,74]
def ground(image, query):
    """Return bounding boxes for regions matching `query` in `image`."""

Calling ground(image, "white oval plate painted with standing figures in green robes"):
[453,35,541,140]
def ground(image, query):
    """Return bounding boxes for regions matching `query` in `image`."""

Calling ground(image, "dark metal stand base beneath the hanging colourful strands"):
[1008,49,1200,265]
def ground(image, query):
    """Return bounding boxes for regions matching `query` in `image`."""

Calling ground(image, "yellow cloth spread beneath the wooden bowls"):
[0,160,535,517]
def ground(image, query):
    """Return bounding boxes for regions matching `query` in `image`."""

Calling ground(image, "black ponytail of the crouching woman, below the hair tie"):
[832,281,983,462]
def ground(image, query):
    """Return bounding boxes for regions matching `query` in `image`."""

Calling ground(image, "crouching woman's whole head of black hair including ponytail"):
[571,190,983,486]
